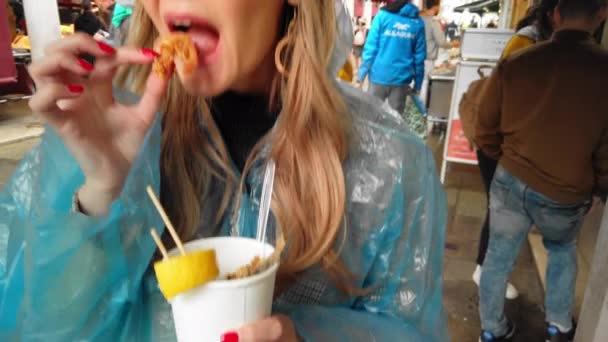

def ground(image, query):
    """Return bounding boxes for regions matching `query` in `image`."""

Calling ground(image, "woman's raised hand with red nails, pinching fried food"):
[29,34,167,215]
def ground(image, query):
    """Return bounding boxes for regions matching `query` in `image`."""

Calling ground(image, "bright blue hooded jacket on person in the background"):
[359,4,426,90]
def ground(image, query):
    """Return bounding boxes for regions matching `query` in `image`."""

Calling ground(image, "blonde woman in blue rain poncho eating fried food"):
[0,0,448,342]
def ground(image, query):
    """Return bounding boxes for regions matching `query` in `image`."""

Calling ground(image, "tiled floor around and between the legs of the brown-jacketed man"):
[429,133,603,342]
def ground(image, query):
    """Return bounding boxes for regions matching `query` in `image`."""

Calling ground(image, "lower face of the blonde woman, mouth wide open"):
[140,0,285,96]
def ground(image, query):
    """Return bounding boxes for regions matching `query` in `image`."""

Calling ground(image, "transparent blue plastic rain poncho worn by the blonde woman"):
[0,3,448,342]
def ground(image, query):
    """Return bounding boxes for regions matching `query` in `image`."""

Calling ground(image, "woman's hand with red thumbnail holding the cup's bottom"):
[221,315,301,342]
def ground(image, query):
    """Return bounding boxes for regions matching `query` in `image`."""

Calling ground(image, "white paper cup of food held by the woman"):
[169,237,278,342]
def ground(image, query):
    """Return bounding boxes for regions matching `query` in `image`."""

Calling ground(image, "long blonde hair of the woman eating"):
[119,0,354,292]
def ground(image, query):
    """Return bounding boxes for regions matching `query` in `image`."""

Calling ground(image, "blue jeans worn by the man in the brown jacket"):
[479,165,591,336]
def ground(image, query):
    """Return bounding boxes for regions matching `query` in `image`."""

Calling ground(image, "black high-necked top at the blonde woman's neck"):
[211,92,277,172]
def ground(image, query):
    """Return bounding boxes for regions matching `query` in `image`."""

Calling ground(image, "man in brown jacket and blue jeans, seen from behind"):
[475,0,608,342]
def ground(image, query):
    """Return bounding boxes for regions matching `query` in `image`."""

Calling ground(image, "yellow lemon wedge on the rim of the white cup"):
[154,250,220,300]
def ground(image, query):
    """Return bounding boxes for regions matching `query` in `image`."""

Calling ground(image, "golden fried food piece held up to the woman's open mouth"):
[152,32,198,78]
